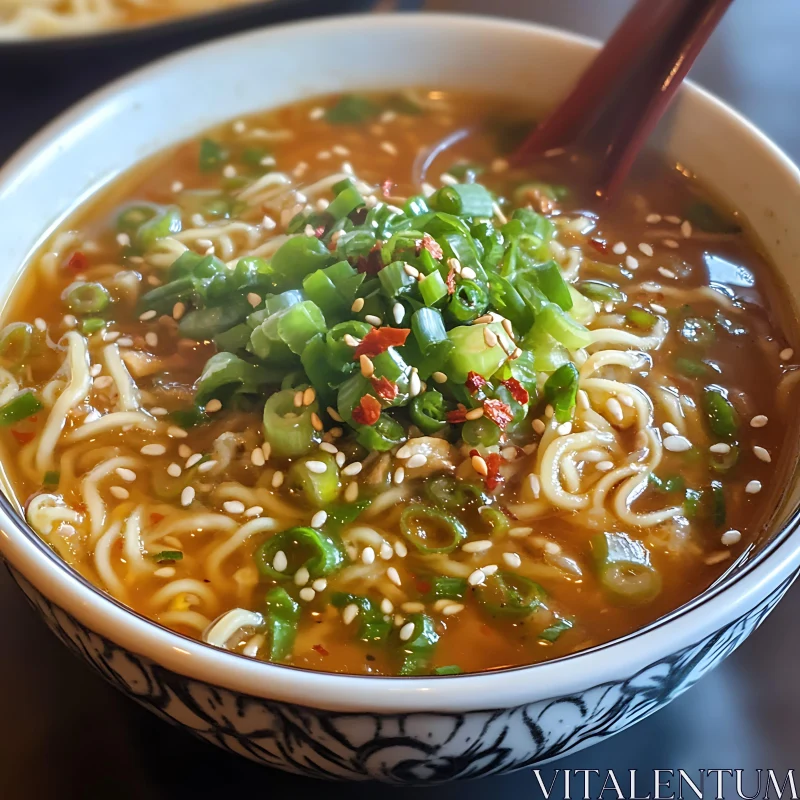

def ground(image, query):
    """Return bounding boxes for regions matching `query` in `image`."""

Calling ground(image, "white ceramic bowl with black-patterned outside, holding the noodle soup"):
[0,15,800,782]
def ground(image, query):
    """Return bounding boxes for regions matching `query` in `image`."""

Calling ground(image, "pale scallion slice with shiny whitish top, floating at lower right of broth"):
[592,533,661,604]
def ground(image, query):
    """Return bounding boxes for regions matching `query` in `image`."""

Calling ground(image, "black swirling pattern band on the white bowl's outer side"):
[9,567,794,784]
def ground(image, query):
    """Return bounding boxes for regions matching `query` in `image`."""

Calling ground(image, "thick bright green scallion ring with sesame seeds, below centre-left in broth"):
[254,528,345,581]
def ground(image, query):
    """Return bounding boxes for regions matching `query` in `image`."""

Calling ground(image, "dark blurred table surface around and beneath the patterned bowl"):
[0,0,800,800]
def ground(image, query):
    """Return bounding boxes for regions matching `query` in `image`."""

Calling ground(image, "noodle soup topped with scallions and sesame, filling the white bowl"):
[0,90,797,675]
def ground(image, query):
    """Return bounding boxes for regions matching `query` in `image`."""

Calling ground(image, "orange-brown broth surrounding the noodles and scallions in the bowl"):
[2,92,797,674]
